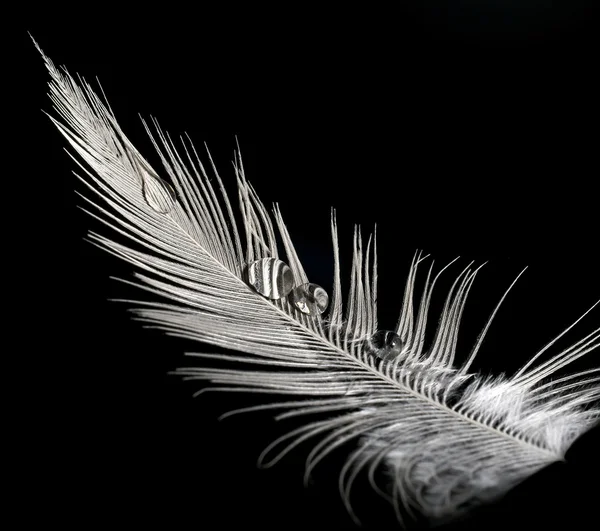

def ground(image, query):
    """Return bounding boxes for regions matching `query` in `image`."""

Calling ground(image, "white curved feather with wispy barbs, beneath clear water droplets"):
[34,40,600,521]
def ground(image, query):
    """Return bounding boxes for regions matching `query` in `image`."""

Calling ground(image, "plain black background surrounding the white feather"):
[21,2,600,529]
